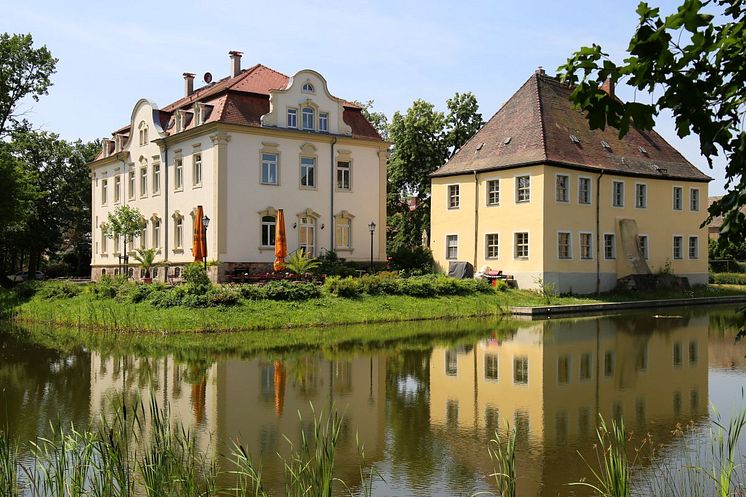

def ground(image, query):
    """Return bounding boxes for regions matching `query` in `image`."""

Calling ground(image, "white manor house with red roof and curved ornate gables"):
[89,52,388,280]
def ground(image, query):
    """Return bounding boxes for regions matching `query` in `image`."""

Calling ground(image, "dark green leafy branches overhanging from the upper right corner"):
[559,0,746,245]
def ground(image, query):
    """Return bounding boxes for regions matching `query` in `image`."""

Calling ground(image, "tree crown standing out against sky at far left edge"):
[0,33,57,137]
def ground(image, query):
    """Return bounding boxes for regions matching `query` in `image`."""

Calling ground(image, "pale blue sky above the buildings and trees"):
[0,0,724,195]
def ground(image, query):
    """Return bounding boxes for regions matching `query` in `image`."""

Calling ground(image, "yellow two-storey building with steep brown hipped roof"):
[430,69,711,293]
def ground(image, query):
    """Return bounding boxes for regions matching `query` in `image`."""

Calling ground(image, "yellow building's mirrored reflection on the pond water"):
[430,316,708,495]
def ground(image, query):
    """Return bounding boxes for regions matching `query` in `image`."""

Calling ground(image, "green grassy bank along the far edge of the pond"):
[0,282,746,334]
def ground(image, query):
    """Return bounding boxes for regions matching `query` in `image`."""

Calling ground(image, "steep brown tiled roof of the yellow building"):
[433,73,711,181]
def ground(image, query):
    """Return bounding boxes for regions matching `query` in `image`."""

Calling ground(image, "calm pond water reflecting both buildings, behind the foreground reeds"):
[0,306,746,496]
